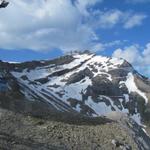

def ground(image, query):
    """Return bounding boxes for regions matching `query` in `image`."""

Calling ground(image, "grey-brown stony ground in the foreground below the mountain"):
[0,109,137,150]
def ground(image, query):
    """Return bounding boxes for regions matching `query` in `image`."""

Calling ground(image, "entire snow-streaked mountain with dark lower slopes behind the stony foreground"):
[0,52,150,149]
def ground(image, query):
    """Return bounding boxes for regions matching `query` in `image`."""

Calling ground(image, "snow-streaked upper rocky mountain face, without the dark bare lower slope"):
[0,51,149,125]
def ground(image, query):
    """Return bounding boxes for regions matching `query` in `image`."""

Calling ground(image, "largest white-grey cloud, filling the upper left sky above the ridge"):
[0,0,102,51]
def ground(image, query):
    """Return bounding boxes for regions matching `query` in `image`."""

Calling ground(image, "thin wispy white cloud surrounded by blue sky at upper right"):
[91,9,147,29]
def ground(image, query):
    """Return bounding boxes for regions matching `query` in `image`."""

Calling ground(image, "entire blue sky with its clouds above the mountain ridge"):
[0,0,150,76]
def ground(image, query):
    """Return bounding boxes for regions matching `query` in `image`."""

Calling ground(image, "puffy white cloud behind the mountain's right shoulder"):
[113,43,150,76]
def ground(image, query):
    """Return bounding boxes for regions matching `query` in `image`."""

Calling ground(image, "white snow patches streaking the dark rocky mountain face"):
[11,54,148,122]
